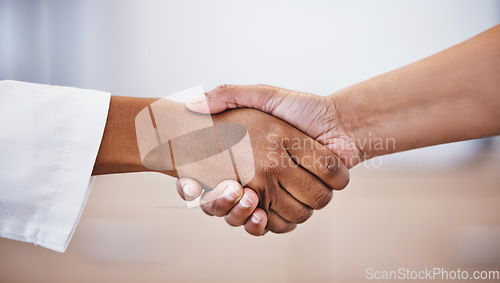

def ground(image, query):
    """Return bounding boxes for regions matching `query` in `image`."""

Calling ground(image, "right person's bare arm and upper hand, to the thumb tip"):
[180,25,500,235]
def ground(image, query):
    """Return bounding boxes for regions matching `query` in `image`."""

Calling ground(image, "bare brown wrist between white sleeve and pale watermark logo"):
[92,96,175,176]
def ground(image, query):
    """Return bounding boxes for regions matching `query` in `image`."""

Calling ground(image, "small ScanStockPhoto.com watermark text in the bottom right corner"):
[365,267,500,280]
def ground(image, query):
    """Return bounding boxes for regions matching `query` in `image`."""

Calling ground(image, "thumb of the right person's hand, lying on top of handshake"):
[186,85,279,114]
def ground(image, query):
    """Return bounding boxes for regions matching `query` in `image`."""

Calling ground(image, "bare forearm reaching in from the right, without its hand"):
[332,23,500,158]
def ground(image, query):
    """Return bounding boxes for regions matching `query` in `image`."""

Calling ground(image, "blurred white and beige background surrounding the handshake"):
[0,0,500,282]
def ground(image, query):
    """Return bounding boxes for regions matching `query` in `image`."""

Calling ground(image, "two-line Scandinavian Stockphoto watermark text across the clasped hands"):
[267,135,396,168]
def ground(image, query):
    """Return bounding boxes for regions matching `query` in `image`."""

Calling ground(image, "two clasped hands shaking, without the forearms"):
[135,85,360,236]
